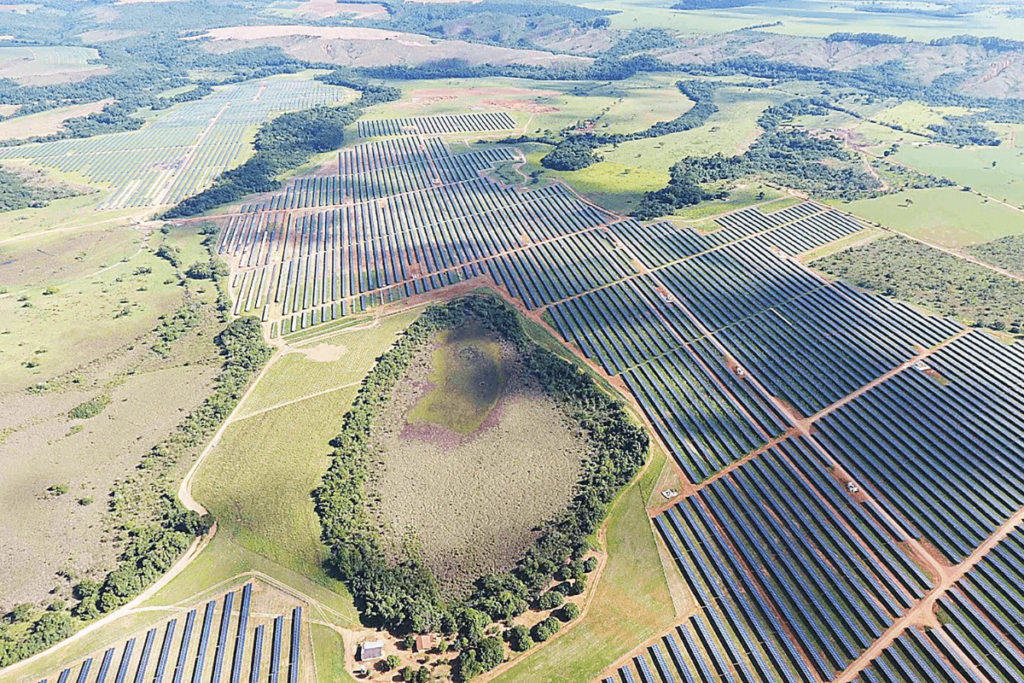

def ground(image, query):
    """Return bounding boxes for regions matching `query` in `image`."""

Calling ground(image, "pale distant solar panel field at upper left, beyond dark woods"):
[0,79,348,209]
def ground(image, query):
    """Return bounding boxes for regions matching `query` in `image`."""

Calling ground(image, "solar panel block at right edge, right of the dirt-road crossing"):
[816,331,1024,562]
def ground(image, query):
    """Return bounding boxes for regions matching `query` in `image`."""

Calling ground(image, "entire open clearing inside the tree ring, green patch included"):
[372,324,587,596]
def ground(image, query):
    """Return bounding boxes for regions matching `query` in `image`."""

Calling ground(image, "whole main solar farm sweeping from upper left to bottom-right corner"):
[219,109,1024,683]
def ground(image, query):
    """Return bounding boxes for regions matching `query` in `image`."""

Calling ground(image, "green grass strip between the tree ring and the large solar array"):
[495,444,677,683]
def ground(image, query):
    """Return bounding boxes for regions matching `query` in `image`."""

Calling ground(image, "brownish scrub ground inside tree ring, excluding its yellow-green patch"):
[373,335,587,595]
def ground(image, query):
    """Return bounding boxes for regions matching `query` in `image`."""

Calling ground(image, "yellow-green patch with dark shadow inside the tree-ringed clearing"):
[407,326,505,435]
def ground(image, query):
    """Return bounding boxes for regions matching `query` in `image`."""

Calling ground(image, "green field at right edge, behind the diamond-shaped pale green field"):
[896,145,1024,207]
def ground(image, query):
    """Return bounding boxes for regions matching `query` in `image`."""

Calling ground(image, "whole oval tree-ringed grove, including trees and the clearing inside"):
[313,295,648,635]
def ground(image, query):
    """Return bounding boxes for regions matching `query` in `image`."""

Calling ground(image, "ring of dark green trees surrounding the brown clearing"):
[313,295,648,680]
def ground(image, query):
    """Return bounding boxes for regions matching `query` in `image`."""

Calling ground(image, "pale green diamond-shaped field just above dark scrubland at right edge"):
[840,187,1024,248]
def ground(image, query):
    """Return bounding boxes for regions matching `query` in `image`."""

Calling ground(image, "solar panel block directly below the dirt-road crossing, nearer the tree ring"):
[656,439,929,681]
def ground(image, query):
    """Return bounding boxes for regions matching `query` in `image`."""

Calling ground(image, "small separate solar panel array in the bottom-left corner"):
[30,583,314,683]
